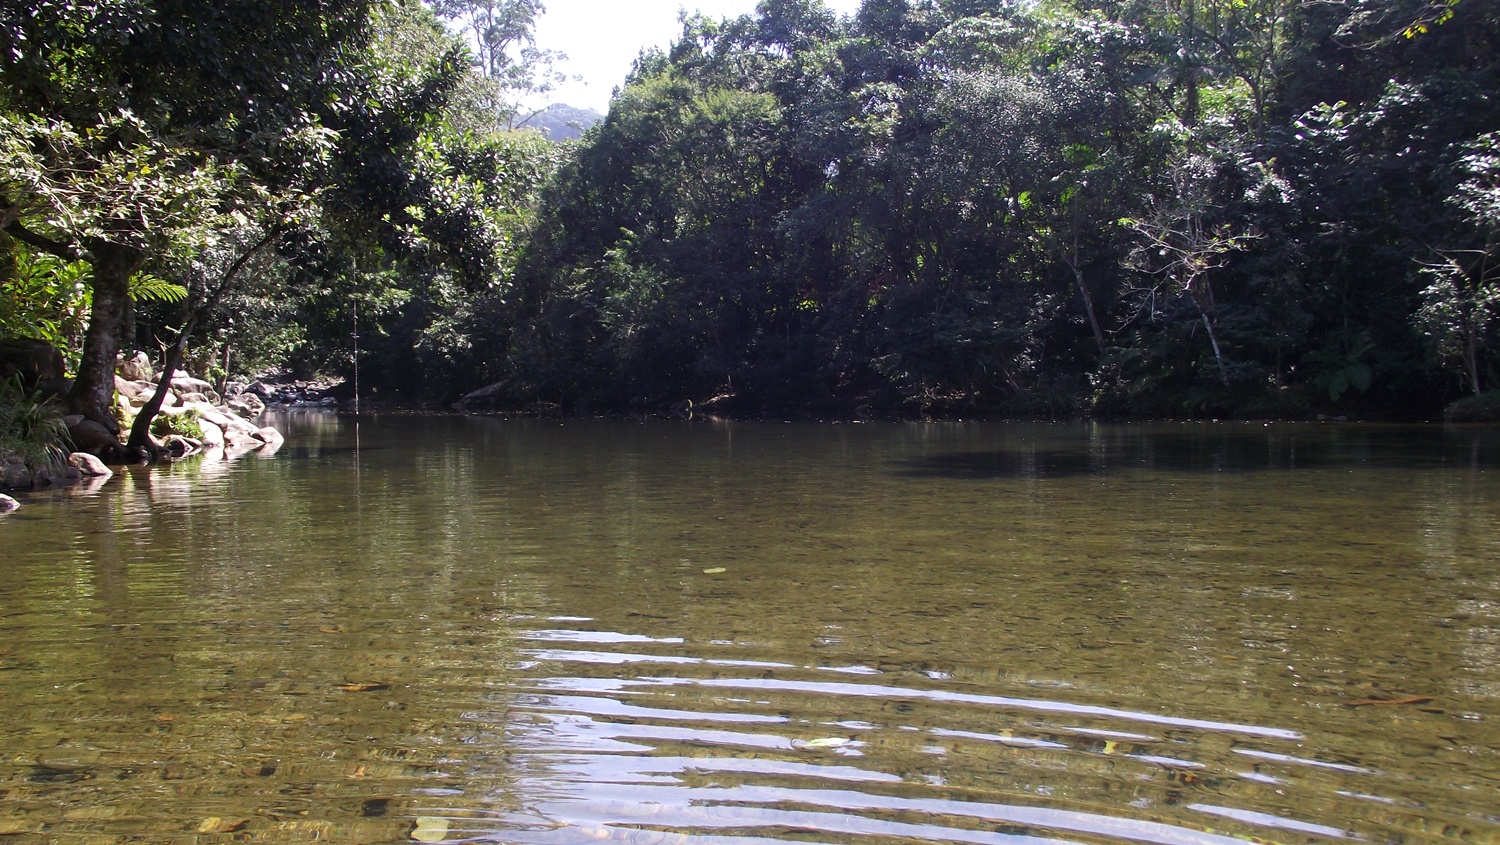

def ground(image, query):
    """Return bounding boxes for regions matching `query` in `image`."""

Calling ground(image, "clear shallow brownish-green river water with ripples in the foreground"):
[0,416,1500,845]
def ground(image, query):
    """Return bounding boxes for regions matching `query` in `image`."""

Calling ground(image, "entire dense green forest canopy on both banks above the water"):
[0,0,1500,419]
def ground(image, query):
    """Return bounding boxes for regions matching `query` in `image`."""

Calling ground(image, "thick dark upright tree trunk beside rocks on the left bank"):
[68,243,143,432]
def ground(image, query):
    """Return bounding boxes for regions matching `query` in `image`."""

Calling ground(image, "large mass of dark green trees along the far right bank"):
[486,0,1500,416]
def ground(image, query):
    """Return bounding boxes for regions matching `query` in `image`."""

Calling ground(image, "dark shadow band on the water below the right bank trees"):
[893,425,1500,480]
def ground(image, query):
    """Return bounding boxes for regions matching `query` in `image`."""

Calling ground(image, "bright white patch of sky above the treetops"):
[537,0,860,113]
